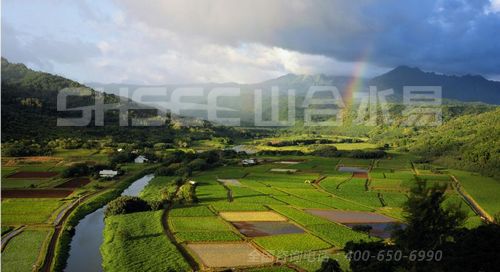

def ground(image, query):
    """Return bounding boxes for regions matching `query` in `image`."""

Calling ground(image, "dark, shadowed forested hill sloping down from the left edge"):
[2,58,246,143]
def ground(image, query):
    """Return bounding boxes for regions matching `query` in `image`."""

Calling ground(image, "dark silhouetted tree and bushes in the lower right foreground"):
[345,179,470,271]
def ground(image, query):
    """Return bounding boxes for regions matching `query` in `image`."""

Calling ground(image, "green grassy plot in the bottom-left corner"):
[2,230,49,272]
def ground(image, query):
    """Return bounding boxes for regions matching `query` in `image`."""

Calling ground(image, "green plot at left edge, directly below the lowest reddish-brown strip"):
[2,198,65,225]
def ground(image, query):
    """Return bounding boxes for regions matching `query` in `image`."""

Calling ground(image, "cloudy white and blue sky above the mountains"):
[1,0,500,84]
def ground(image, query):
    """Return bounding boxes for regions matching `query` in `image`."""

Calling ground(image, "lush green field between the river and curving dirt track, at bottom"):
[101,211,190,271]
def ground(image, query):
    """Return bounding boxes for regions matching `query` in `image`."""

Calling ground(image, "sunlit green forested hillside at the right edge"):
[410,108,500,177]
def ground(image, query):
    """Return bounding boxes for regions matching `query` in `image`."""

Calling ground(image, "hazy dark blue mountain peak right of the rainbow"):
[368,66,500,104]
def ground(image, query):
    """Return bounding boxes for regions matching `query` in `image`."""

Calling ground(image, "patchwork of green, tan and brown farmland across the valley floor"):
[2,143,498,271]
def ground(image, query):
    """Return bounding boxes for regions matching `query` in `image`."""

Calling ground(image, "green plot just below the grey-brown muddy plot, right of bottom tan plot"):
[254,233,331,257]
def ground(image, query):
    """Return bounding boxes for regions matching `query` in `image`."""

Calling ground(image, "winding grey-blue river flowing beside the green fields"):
[64,175,154,272]
